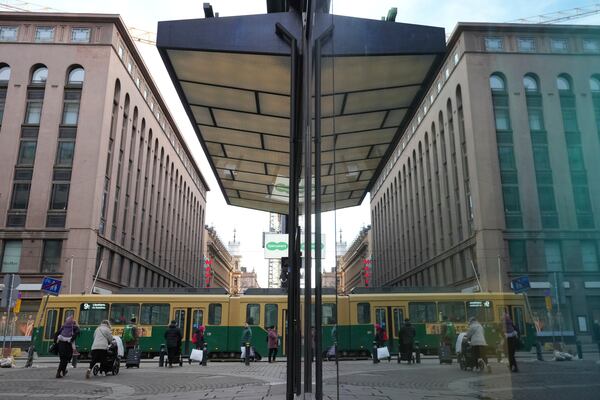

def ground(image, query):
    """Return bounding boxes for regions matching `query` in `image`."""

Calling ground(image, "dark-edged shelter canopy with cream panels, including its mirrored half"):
[157,13,445,214]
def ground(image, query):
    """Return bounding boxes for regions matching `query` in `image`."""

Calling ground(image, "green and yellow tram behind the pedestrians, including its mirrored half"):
[35,289,534,358]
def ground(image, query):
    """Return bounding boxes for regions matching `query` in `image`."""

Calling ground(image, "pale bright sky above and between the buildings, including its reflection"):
[8,0,600,287]
